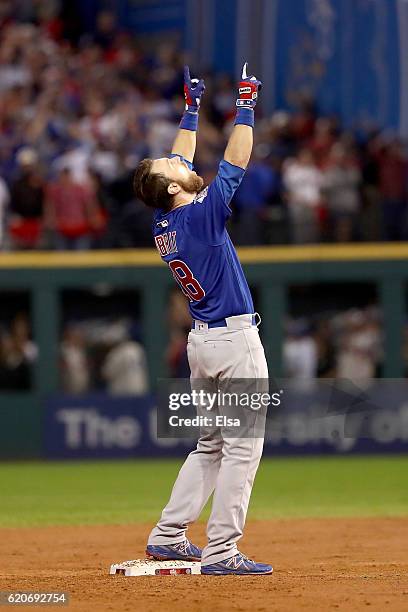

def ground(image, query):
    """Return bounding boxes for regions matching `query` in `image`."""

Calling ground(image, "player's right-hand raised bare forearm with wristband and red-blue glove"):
[224,63,262,168]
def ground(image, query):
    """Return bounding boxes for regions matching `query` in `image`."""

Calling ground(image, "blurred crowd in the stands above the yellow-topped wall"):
[0,0,408,250]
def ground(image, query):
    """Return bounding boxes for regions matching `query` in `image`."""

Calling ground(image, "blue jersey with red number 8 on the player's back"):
[153,155,254,323]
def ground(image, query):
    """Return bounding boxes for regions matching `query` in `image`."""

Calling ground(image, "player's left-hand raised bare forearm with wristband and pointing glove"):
[171,66,205,162]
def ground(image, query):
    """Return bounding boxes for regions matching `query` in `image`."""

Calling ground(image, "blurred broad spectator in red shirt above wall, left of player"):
[45,168,102,251]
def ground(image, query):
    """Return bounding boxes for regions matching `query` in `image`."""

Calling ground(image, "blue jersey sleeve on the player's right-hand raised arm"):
[189,159,245,245]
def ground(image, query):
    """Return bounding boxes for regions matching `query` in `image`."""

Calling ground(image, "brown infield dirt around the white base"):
[0,518,408,612]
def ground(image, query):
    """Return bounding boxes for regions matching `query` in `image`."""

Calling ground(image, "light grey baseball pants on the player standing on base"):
[148,315,268,565]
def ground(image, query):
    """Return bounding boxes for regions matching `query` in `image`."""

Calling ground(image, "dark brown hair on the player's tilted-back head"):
[133,158,173,210]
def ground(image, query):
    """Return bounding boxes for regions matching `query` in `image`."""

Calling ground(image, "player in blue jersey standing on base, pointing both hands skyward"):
[134,64,272,575]
